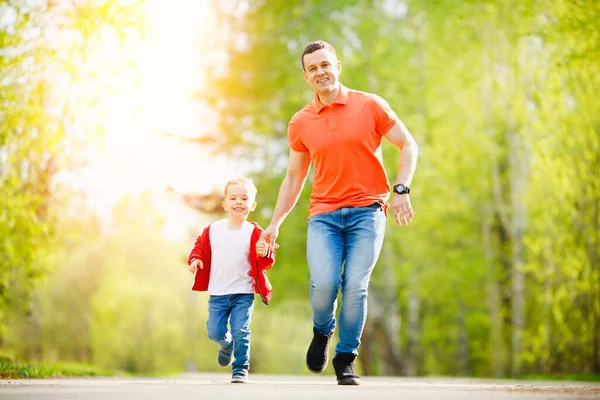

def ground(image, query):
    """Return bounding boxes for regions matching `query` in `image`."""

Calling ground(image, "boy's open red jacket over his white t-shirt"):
[188,222,275,305]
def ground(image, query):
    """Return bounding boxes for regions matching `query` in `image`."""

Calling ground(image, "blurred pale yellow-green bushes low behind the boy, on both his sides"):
[5,194,318,375]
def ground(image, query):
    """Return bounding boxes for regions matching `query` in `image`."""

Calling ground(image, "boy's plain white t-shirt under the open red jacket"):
[208,219,254,295]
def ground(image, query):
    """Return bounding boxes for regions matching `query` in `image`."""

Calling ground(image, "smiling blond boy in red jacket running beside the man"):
[188,178,275,383]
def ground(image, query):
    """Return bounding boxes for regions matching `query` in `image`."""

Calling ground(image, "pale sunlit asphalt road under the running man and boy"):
[0,373,600,400]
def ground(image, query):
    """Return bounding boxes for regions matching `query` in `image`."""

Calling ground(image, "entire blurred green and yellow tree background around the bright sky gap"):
[0,0,600,377]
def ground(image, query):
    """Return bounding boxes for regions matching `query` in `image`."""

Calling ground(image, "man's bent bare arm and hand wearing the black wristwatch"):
[385,121,419,225]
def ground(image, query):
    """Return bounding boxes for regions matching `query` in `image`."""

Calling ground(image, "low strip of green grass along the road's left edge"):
[0,356,117,379]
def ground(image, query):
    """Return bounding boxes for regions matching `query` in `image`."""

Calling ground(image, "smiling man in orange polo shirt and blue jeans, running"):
[262,41,418,385]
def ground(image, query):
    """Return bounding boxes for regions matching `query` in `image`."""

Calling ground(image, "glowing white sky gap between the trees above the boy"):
[56,0,244,223]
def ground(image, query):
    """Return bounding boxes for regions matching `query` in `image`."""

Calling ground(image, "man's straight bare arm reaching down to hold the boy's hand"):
[261,149,310,248]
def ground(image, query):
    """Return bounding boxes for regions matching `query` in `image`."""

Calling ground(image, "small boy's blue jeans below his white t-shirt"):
[206,293,254,372]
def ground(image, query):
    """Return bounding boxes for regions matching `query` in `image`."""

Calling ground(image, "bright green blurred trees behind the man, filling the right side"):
[202,0,600,376]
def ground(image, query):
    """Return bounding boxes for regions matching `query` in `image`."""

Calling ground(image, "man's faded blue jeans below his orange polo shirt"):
[306,204,386,355]
